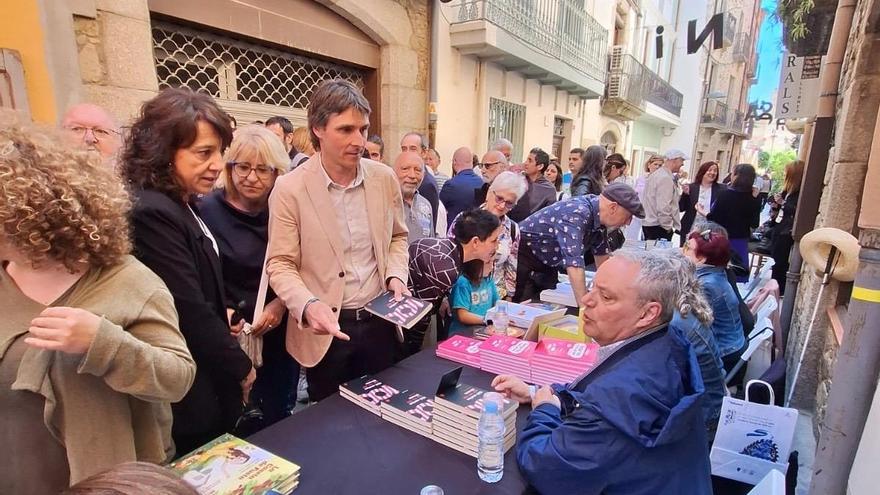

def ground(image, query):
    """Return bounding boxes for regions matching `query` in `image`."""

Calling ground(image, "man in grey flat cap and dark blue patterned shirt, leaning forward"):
[513,183,645,302]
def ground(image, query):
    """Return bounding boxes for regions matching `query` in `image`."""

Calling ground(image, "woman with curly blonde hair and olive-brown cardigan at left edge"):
[0,112,195,493]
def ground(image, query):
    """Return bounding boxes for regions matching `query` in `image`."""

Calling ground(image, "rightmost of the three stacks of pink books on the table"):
[531,338,599,385]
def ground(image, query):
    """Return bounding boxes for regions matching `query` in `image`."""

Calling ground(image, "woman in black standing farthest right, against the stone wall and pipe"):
[770,160,804,295]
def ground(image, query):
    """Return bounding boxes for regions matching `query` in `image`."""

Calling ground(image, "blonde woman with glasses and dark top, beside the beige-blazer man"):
[199,126,299,426]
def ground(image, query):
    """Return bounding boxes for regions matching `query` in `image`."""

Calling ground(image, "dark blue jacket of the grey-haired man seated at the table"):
[517,328,712,495]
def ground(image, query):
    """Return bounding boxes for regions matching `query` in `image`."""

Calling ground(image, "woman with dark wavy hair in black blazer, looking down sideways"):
[122,88,256,453]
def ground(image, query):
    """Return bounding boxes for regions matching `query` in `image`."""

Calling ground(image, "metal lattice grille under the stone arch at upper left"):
[152,22,365,109]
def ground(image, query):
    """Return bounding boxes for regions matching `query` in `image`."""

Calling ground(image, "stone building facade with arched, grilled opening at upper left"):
[0,0,430,149]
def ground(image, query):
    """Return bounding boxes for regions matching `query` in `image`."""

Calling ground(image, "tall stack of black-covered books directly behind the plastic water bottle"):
[432,383,519,457]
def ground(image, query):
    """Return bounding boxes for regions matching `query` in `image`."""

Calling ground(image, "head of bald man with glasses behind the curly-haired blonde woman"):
[61,103,122,167]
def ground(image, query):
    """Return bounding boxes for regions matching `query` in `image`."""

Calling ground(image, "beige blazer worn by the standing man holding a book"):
[266,153,409,367]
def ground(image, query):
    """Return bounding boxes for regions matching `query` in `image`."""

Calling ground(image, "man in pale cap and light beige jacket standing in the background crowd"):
[642,149,688,241]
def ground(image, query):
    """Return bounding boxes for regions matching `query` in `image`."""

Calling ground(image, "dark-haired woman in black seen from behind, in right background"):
[706,163,761,282]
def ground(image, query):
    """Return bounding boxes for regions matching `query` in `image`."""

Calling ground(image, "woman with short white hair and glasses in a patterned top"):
[447,172,528,300]
